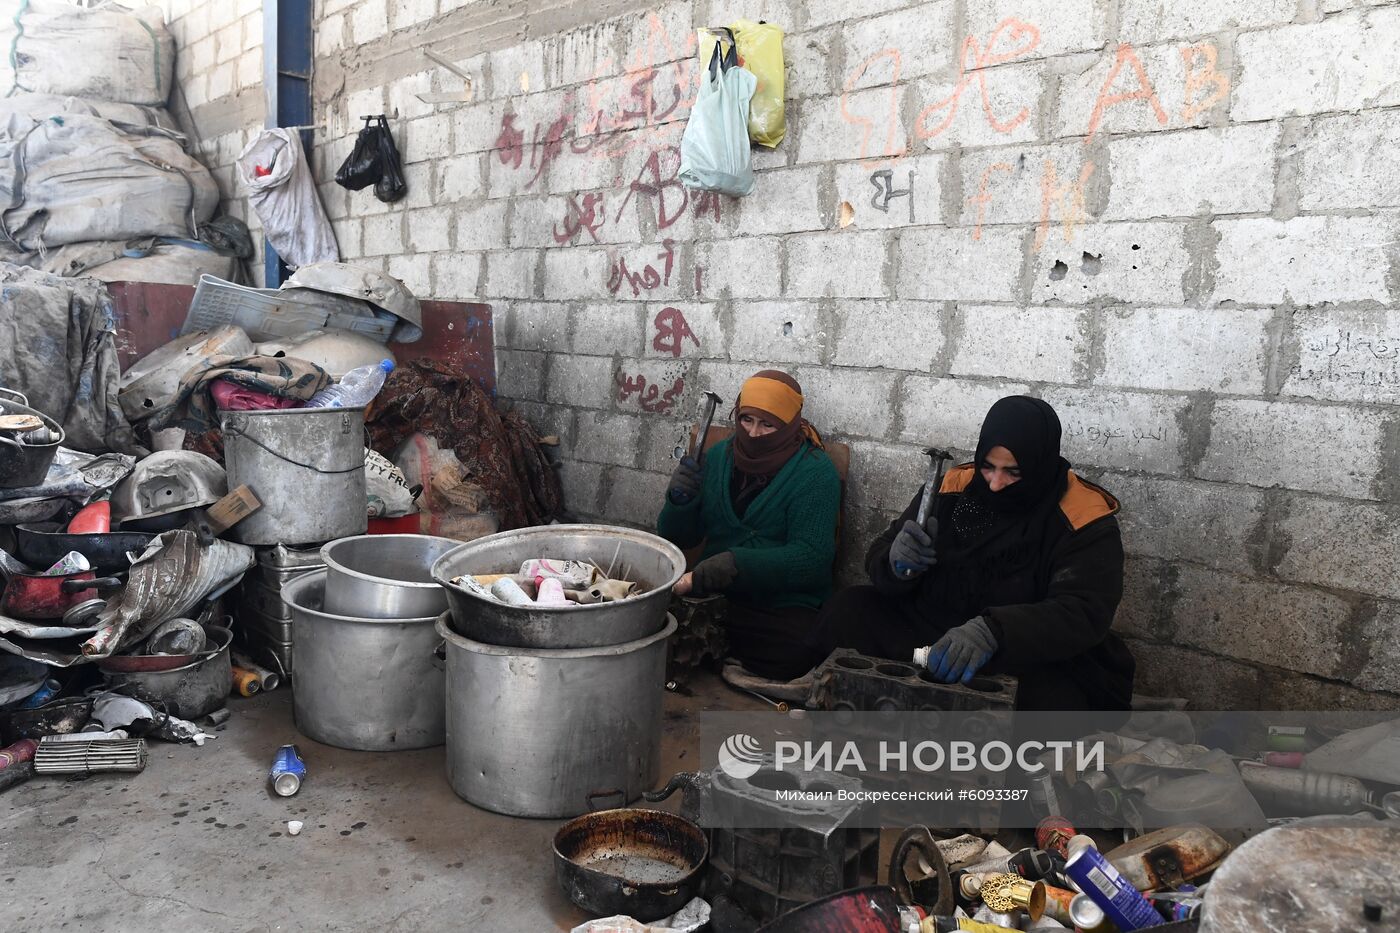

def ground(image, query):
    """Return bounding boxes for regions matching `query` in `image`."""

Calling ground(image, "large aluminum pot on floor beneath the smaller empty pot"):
[281,570,447,751]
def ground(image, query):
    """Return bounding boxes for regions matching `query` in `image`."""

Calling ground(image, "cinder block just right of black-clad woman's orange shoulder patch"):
[1093,474,1264,574]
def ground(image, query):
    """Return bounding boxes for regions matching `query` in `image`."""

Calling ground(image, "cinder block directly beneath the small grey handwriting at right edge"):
[1196,399,1387,499]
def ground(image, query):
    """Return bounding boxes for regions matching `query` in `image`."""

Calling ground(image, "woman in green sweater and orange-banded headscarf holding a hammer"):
[657,370,841,679]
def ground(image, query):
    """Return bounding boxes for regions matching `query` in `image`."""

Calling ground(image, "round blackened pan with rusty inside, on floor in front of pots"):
[554,807,710,923]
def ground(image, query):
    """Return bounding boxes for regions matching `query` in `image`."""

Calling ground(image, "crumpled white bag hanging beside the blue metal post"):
[238,127,340,268]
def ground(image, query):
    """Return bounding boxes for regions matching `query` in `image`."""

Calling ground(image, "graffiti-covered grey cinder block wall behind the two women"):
[156,0,1400,707]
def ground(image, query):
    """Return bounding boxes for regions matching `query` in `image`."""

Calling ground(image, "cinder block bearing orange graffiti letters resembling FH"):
[959,143,1086,228]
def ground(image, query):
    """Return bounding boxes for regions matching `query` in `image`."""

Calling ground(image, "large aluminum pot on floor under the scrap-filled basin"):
[439,614,676,818]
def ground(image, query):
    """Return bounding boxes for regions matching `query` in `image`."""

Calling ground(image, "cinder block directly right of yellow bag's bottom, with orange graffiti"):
[783,87,910,168]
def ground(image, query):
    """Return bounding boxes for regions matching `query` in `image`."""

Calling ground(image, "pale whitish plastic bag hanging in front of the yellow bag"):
[680,42,757,198]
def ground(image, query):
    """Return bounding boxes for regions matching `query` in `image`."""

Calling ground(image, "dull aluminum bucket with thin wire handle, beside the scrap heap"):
[220,408,370,545]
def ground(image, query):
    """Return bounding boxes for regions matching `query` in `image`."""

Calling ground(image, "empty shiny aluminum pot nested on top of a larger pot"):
[321,535,462,619]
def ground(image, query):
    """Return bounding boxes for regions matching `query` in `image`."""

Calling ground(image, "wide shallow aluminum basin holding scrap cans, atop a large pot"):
[433,525,686,649]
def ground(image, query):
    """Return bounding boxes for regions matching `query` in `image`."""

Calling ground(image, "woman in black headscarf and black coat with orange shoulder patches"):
[812,395,1134,710]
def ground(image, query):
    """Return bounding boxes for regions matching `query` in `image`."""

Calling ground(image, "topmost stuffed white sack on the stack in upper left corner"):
[0,0,175,106]
